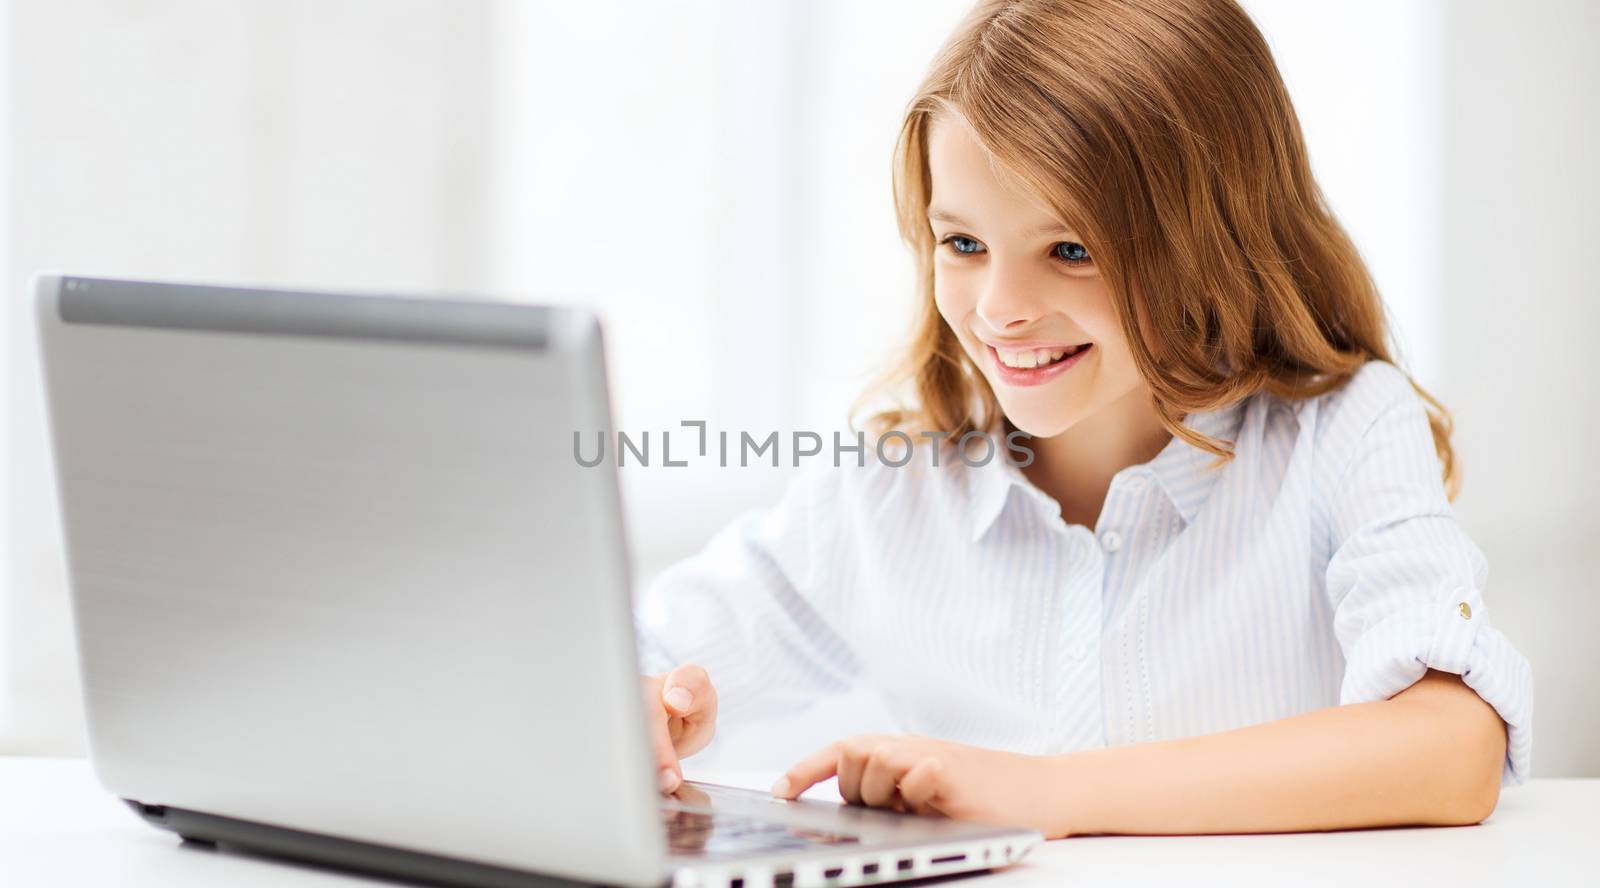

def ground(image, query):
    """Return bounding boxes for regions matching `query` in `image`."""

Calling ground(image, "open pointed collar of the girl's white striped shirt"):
[968,402,1245,542]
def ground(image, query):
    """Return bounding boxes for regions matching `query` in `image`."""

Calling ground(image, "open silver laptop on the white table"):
[34,274,1042,888]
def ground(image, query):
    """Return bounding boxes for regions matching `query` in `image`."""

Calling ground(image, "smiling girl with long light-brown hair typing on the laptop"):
[638,0,1533,837]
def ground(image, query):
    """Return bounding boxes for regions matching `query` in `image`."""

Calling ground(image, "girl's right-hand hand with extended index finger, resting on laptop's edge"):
[773,734,1066,838]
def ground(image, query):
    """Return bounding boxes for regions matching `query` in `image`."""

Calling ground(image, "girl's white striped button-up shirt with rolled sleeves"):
[637,362,1533,786]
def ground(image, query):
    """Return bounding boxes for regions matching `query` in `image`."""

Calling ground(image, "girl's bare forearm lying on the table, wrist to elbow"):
[1050,670,1506,835]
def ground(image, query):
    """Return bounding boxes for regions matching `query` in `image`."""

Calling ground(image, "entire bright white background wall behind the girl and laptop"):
[0,0,1600,776]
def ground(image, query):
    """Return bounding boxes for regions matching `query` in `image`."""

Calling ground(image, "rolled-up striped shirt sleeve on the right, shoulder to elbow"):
[1326,368,1533,786]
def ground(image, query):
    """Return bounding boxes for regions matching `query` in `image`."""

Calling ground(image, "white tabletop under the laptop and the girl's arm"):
[0,757,1600,888]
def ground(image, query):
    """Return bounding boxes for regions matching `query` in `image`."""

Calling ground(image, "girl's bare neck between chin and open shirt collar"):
[1022,386,1173,530]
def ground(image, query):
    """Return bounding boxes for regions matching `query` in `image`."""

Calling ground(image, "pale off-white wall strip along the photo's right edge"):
[1438,0,1600,776]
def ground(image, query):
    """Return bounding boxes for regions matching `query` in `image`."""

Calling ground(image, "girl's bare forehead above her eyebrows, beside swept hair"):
[928,112,1054,230]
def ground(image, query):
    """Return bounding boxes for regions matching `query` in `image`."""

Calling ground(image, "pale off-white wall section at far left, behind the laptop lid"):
[0,0,490,752]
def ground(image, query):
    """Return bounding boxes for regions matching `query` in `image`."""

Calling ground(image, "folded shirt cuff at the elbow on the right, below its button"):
[1339,589,1533,787]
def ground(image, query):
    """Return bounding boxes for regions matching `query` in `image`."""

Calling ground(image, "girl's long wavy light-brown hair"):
[853,0,1461,499]
